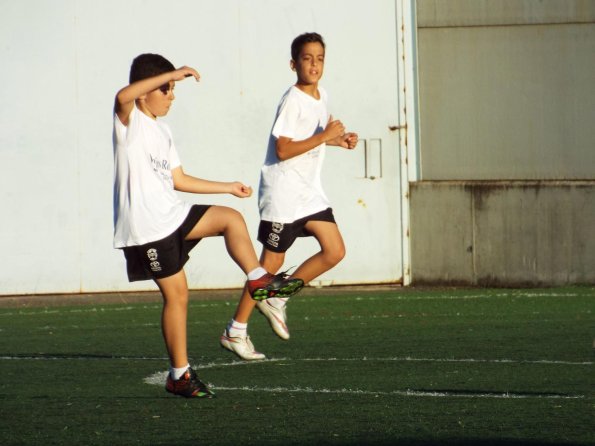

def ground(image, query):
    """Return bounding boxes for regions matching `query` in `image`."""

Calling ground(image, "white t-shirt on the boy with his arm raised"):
[113,106,190,248]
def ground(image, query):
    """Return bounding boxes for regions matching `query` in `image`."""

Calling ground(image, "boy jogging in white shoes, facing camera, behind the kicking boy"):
[220,33,358,360]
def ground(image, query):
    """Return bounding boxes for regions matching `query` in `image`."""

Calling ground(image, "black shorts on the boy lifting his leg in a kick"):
[122,205,210,282]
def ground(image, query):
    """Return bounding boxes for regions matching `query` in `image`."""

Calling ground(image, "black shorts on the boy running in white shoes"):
[258,208,336,252]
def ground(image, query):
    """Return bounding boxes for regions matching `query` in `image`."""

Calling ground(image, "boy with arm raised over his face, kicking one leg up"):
[113,54,303,398]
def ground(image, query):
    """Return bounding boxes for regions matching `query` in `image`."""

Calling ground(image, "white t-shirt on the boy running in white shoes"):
[258,86,330,223]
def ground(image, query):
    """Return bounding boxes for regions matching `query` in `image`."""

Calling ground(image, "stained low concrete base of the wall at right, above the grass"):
[411,182,595,286]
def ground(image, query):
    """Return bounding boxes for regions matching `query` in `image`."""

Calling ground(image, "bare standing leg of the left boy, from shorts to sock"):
[155,270,188,367]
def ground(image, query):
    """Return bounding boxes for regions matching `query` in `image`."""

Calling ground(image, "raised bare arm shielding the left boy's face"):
[114,66,200,125]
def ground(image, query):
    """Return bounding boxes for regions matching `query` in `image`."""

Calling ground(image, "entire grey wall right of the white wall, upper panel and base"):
[411,0,595,286]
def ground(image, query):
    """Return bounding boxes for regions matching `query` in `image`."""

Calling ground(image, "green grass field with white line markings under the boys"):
[0,287,595,446]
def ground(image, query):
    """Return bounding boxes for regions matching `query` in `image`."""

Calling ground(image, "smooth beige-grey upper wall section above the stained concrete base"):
[417,0,595,180]
